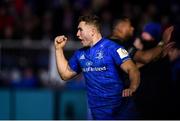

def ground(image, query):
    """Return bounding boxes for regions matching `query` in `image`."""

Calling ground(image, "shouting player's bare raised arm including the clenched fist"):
[54,35,76,80]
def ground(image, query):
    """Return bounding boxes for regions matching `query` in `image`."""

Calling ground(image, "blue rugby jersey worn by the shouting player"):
[69,38,130,108]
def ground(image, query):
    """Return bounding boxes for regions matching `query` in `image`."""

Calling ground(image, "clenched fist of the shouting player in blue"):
[54,35,67,49]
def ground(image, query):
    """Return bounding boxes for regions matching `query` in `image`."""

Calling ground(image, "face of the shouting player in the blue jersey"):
[76,21,93,47]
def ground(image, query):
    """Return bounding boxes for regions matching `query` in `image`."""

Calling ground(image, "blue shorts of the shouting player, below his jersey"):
[91,98,140,120]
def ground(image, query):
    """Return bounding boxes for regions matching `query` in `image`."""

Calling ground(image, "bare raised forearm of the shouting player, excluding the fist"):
[55,49,76,80]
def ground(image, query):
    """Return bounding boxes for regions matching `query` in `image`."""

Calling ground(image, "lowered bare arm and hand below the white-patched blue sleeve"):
[121,59,140,97]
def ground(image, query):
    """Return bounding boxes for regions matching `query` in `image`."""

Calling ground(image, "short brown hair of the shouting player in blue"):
[78,15,101,32]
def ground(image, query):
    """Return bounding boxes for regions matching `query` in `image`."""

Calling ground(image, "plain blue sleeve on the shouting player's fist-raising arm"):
[68,51,81,73]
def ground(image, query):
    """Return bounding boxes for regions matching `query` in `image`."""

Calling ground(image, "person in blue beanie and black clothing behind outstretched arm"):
[136,23,173,120]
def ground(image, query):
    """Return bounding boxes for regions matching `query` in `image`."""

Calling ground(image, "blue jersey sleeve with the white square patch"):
[110,46,131,65]
